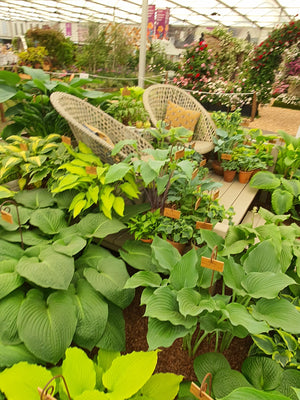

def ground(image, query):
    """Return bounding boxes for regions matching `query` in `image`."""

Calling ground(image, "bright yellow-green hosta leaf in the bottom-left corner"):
[0,362,55,400]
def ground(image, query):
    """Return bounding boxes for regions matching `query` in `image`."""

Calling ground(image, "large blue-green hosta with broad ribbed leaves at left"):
[0,189,134,368]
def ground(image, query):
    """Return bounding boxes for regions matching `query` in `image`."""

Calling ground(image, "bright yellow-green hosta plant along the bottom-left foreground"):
[0,347,183,400]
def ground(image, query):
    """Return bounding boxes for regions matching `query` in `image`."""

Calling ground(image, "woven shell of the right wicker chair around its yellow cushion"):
[143,84,216,154]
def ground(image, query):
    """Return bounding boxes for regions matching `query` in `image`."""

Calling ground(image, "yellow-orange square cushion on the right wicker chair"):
[165,100,201,132]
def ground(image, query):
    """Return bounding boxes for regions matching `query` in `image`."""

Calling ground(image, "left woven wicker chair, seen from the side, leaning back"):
[50,92,152,164]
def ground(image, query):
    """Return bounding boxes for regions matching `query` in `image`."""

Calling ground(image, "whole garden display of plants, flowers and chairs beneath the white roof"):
[0,8,300,400]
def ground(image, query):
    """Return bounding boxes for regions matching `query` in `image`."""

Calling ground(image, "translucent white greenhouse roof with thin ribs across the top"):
[0,0,300,28]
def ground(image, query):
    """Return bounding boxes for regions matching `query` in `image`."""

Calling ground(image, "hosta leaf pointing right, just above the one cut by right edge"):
[241,272,296,299]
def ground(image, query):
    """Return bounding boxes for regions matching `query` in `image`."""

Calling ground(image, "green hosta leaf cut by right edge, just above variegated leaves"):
[252,299,300,334]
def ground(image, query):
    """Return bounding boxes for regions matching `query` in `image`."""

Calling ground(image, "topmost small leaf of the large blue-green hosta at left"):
[15,189,55,210]
